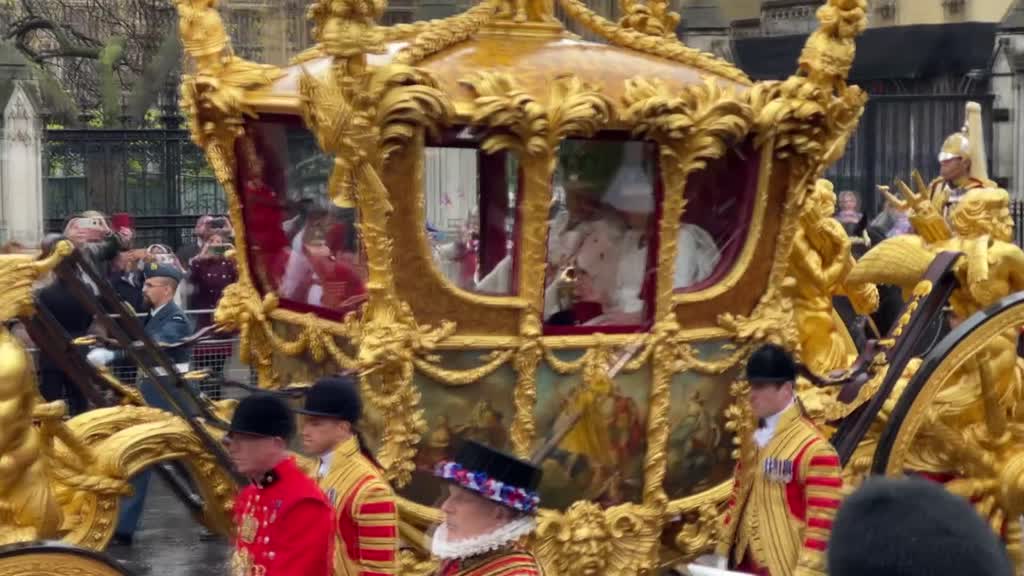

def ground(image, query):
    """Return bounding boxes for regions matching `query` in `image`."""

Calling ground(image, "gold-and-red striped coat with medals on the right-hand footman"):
[717,402,843,576]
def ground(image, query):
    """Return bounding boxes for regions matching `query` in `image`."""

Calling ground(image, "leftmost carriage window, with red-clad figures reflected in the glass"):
[237,117,368,318]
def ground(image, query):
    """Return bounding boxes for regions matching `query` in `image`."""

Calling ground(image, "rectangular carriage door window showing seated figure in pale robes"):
[544,140,659,332]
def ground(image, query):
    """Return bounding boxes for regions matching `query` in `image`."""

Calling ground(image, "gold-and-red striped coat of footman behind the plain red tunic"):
[319,437,398,576]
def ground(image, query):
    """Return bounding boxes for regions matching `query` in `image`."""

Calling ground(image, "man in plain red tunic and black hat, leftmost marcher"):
[225,394,332,576]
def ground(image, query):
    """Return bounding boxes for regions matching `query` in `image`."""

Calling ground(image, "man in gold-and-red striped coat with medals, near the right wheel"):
[716,344,843,576]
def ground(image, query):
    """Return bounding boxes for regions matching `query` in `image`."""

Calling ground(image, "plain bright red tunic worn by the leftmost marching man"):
[231,458,332,576]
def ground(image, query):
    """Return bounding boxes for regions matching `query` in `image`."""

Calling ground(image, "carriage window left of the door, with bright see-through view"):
[424,129,519,294]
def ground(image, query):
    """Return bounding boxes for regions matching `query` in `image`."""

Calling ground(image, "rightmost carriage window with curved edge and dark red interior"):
[674,139,760,292]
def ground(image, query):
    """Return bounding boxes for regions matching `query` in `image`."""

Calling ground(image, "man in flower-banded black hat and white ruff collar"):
[431,441,544,576]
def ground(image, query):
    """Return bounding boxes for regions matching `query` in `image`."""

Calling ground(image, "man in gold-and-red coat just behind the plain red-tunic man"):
[299,376,398,576]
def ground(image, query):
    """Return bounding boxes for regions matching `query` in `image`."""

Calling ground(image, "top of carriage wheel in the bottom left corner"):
[0,542,132,576]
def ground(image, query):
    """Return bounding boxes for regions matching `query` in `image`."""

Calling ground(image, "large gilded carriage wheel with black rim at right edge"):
[871,292,1024,568]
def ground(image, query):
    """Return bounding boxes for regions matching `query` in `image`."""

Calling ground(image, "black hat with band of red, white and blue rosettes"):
[435,440,542,513]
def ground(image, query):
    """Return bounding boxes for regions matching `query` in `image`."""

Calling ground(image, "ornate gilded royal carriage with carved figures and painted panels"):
[0,0,1024,574]
